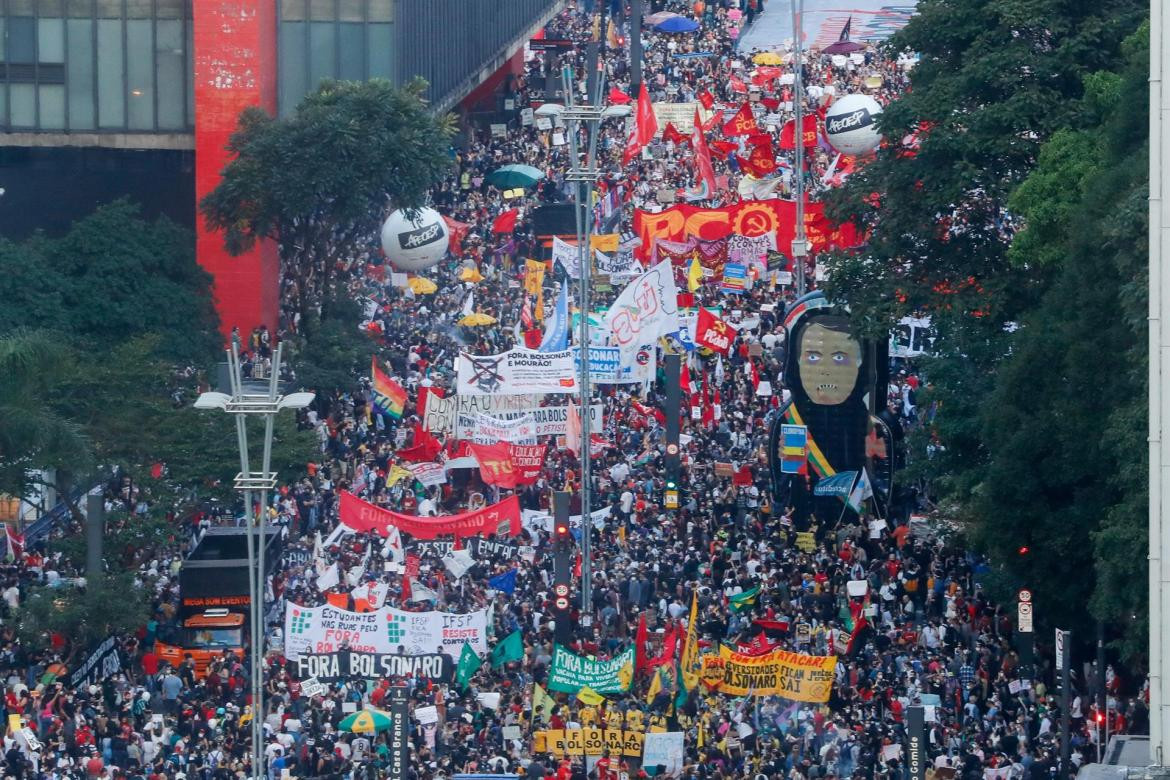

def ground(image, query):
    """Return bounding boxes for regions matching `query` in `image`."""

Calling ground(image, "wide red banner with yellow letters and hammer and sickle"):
[634,199,861,262]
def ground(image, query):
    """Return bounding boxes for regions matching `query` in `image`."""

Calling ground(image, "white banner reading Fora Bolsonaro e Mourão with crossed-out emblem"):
[455,347,577,395]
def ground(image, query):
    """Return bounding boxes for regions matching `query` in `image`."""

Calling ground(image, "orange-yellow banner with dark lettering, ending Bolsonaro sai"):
[702,647,837,703]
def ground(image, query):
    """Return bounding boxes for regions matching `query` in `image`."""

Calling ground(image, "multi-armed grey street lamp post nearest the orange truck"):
[195,344,314,778]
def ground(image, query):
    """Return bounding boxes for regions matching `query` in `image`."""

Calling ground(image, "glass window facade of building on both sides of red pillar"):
[0,0,559,133]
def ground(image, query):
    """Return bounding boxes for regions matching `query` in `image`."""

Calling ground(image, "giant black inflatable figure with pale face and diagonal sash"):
[769,292,893,531]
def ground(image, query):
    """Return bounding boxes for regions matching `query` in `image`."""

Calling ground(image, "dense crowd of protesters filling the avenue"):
[0,0,1147,780]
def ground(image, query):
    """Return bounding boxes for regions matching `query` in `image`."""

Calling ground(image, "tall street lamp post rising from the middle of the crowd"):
[536,68,629,627]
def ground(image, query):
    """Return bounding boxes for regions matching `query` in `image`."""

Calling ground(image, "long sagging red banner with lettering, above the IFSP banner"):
[338,490,521,539]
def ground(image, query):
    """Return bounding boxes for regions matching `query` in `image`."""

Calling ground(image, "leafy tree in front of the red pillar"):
[200,80,453,316]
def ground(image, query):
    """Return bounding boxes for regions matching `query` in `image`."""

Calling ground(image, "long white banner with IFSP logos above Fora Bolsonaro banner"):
[284,602,488,661]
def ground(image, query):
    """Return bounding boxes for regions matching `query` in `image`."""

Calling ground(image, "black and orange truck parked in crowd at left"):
[156,527,282,675]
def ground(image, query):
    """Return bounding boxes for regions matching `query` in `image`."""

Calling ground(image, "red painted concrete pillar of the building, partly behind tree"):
[192,0,280,345]
